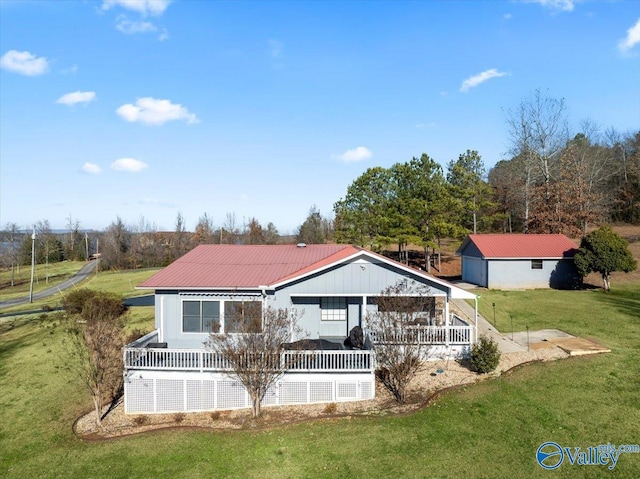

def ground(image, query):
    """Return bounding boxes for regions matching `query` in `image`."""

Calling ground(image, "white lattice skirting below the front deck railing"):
[124,371,375,414]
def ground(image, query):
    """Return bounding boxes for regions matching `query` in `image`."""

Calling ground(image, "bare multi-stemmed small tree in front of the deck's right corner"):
[367,282,434,403]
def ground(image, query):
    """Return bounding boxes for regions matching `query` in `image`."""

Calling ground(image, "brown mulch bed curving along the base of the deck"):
[73,347,568,441]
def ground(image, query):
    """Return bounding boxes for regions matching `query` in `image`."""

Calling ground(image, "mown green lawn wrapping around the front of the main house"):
[0,284,640,478]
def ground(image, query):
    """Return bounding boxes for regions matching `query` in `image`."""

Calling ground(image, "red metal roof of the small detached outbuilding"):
[458,234,578,258]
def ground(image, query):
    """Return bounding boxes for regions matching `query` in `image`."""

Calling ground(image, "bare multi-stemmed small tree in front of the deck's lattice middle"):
[206,302,301,418]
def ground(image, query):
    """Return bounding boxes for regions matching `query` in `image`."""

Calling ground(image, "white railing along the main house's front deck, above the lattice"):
[123,347,374,372]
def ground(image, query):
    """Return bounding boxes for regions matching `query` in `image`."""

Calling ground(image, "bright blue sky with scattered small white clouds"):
[0,0,640,233]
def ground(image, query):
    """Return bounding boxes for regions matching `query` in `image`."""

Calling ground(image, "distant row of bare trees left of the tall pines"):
[0,206,333,276]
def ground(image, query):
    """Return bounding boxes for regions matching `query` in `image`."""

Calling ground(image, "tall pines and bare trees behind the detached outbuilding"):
[334,90,640,262]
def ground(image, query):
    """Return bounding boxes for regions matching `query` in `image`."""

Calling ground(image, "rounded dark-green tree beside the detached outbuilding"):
[574,226,638,291]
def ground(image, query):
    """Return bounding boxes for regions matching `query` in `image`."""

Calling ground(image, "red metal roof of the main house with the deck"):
[139,245,360,289]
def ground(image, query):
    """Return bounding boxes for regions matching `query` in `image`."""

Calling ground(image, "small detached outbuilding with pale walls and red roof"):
[456,234,580,289]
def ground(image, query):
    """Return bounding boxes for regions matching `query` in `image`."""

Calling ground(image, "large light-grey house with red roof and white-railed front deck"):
[124,244,477,413]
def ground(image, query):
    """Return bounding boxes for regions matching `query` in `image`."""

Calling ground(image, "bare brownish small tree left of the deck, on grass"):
[63,290,127,426]
